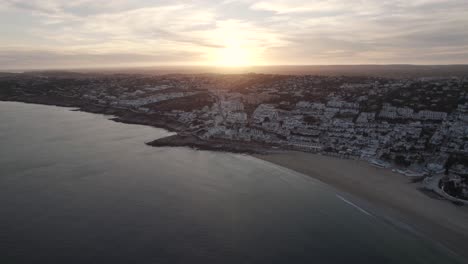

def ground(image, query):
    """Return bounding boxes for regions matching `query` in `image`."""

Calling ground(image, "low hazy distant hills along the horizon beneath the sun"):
[0,64,468,78]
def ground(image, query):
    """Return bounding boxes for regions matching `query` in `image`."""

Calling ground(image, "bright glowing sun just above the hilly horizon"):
[216,45,252,67]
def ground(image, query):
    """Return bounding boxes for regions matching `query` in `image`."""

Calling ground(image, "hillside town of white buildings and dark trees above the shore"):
[0,73,468,200]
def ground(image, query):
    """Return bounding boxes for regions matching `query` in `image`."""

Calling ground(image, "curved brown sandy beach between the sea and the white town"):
[254,152,468,259]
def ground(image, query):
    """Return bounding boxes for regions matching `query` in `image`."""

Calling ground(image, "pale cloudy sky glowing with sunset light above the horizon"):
[0,0,468,69]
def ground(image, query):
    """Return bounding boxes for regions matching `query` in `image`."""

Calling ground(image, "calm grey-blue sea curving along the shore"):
[0,102,460,263]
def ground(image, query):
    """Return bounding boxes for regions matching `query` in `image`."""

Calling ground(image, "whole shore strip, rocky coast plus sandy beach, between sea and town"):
[0,98,468,259]
